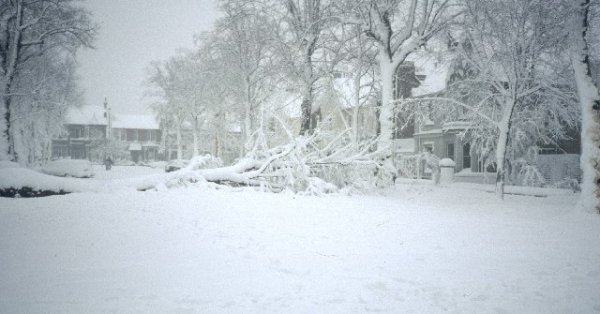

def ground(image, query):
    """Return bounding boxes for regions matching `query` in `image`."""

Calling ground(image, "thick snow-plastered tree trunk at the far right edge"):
[571,0,600,212]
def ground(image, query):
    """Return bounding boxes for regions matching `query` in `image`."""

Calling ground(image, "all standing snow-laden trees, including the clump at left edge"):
[0,0,600,207]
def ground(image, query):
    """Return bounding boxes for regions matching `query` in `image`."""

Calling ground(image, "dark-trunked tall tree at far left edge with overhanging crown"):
[0,0,95,160]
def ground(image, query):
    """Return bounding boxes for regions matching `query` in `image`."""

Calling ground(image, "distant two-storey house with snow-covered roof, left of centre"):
[52,106,161,162]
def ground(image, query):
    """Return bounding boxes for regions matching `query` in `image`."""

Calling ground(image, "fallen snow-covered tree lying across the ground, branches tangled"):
[0,110,395,196]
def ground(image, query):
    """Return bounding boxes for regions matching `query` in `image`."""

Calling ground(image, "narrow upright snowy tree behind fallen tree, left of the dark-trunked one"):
[211,0,280,156]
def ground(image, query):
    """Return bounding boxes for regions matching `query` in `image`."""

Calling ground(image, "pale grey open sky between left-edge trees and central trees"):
[77,0,216,113]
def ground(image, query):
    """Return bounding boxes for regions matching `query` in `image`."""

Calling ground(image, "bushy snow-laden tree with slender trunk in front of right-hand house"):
[414,0,579,198]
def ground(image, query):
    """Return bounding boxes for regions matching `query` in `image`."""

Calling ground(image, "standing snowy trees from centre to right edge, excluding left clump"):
[148,0,600,206]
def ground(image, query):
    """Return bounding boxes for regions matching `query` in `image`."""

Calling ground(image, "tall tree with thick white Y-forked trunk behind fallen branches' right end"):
[343,0,461,154]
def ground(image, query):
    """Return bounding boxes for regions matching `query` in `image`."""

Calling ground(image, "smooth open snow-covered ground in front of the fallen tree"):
[0,167,600,313]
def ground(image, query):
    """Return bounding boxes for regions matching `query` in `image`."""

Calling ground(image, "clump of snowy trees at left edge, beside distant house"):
[0,0,97,165]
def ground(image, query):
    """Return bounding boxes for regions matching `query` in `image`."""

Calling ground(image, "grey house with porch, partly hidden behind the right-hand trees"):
[403,55,580,183]
